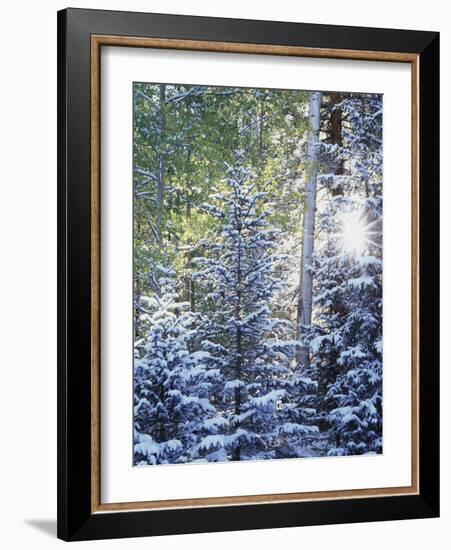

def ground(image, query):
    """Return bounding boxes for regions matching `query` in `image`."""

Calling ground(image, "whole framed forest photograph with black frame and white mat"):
[58,9,439,540]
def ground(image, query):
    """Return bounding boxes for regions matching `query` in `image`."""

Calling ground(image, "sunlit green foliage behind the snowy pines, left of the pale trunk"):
[133,83,308,310]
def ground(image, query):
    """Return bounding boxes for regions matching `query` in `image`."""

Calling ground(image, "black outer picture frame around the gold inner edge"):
[58,9,439,540]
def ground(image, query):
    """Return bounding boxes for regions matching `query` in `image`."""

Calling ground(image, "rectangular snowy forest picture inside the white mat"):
[133,83,383,466]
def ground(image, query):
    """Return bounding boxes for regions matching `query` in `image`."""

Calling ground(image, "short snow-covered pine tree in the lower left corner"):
[134,277,219,465]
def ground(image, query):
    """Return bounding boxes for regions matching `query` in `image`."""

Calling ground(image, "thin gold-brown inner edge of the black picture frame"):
[90,35,420,514]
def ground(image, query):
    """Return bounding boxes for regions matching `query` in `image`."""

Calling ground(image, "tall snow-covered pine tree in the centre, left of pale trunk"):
[197,158,316,460]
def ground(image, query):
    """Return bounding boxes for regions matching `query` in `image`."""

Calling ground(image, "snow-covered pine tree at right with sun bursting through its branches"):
[308,95,382,455]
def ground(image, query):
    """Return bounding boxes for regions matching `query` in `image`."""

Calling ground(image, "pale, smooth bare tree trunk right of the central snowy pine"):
[296,92,321,368]
